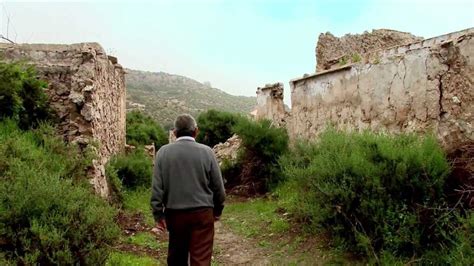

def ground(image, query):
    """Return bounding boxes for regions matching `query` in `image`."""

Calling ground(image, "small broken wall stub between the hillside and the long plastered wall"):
[255,83,288,126]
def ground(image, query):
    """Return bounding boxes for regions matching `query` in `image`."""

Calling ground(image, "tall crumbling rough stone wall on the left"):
[0,43,126,197]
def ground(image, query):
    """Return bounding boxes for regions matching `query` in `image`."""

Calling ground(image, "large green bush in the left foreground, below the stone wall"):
[0,120,119,265]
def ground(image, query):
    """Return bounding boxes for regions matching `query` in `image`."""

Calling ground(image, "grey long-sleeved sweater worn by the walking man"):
[151,137,225,221]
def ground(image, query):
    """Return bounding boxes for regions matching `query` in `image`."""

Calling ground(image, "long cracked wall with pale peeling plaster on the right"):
[288,28,474,150]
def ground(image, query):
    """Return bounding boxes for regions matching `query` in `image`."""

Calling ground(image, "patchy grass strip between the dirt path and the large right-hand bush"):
[222,196,347,265]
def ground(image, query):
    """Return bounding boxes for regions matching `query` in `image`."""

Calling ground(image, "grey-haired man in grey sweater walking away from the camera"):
[151,114,225,265]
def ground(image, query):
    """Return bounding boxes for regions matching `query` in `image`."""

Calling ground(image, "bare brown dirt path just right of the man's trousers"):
[214,222,270,265]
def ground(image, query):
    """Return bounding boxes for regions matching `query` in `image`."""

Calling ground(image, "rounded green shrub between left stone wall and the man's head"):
[127,111,168,150]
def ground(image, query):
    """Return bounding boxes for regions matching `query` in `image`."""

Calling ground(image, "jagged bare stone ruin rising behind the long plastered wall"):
[316,29,423,72]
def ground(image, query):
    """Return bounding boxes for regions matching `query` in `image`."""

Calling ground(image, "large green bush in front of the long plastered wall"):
[277,129,470,260]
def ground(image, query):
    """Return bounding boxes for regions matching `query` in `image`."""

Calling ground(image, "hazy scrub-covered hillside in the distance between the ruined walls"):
[126,69,256,127]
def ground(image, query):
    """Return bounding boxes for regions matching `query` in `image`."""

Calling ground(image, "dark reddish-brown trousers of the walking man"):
[166,208,214,266]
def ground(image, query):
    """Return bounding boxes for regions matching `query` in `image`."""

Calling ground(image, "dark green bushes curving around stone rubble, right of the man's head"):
[197,110,288,194]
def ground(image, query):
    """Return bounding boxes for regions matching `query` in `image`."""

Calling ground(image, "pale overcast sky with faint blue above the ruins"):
[1,0,474,102]
